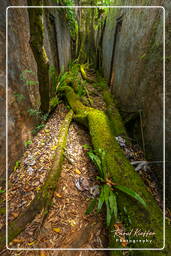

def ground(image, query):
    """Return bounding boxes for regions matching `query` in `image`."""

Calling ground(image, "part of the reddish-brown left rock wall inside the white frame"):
[8,1,39,177]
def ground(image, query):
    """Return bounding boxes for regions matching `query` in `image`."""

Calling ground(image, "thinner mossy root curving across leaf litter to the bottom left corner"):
[0,110,73,249]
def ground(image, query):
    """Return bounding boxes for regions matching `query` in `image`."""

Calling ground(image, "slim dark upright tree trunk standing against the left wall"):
[28,0,49,113]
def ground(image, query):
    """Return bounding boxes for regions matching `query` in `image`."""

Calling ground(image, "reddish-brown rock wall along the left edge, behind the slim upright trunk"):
[0,0,36,183]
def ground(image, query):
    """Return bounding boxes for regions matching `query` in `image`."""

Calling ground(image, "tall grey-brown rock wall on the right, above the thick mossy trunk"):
[102,0,171,206]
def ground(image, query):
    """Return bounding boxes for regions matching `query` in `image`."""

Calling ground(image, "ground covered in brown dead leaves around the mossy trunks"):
[0,77,166,256]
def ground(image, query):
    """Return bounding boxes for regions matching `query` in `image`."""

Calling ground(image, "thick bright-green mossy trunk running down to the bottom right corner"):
[63,86,171,255]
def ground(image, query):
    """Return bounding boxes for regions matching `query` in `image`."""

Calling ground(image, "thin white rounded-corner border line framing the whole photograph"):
[6,6,166,251]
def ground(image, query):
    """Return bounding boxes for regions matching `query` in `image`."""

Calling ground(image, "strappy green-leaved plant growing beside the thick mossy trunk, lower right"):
[86,149,147,226]
